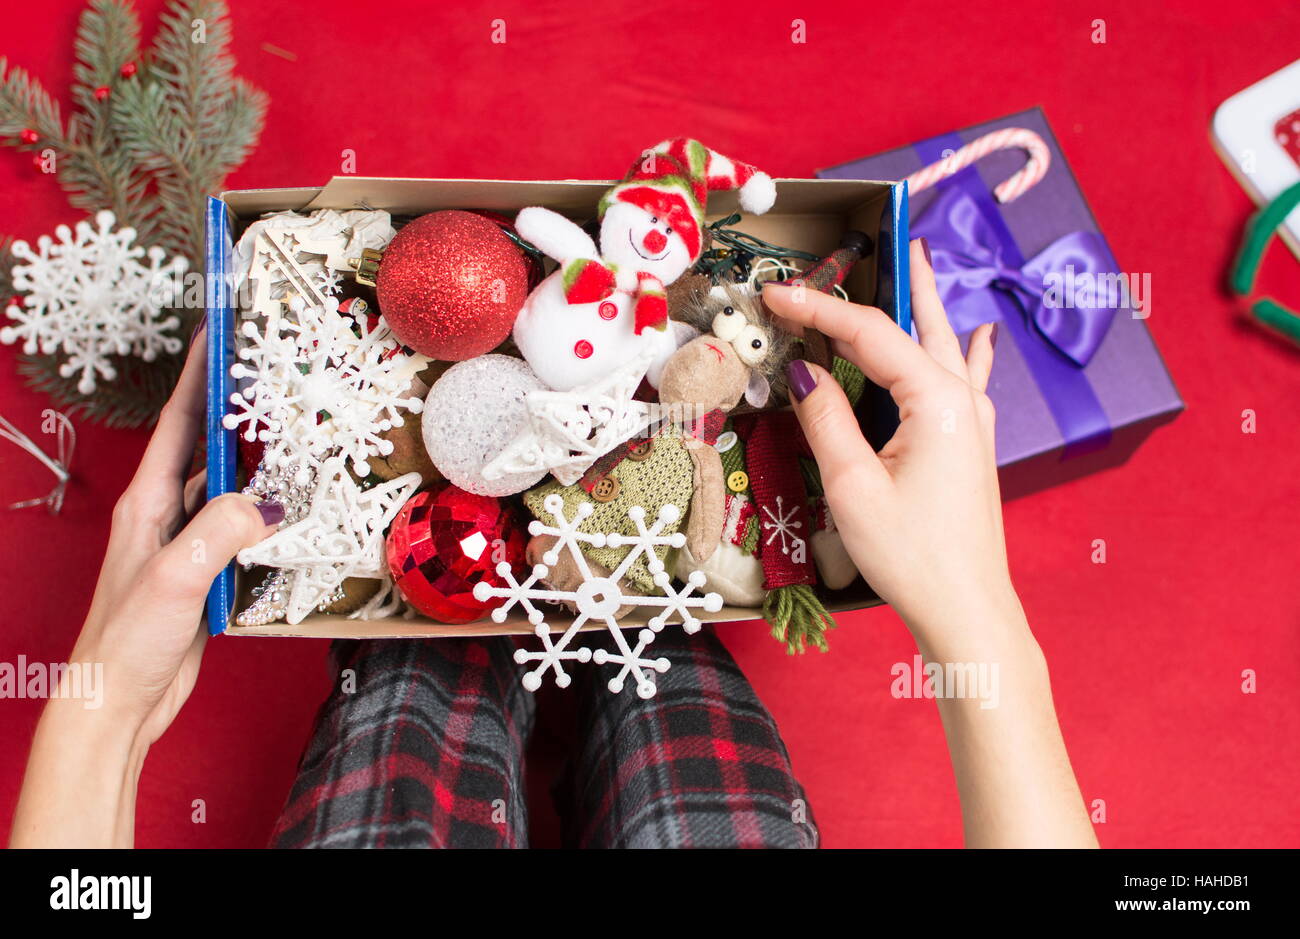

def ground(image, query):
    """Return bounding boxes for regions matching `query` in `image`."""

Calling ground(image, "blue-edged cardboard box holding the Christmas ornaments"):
[207,177,911,639]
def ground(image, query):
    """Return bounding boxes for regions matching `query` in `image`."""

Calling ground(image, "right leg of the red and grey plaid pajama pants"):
[556,628,818,848]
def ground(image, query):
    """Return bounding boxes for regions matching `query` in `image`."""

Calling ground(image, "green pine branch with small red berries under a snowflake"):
[0,0,268,427]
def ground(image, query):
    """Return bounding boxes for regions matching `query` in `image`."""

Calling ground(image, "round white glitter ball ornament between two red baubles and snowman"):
[423,355,546,496]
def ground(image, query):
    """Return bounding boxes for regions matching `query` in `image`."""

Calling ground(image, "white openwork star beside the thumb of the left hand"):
[239,456,421,624]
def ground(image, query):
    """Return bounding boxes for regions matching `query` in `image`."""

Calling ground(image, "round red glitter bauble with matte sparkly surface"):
[374,209,529,362]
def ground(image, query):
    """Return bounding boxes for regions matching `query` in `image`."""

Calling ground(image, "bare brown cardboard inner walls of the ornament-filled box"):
[209,177,910,639]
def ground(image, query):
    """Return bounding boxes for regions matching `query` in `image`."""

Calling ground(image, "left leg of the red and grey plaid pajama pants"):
[272,639,536,848]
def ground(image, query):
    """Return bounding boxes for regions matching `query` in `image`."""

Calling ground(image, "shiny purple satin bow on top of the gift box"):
[911,186,1123,368]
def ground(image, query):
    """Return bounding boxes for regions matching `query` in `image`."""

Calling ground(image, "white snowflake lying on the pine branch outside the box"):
[0,211,186,394]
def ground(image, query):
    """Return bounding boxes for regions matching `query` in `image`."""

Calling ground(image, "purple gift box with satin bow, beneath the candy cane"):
[818,108,1183,497]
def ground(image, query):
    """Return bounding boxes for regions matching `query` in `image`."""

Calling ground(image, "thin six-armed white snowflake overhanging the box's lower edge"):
[475,493,723,698]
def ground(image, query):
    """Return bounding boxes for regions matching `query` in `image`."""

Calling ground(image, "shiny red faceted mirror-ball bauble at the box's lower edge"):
[387,483,527,623]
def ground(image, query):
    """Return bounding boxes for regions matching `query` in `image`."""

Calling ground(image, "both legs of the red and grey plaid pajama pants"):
[272,631,818,848]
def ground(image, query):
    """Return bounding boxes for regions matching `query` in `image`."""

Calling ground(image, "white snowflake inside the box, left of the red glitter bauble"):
[224,297,424,477]
